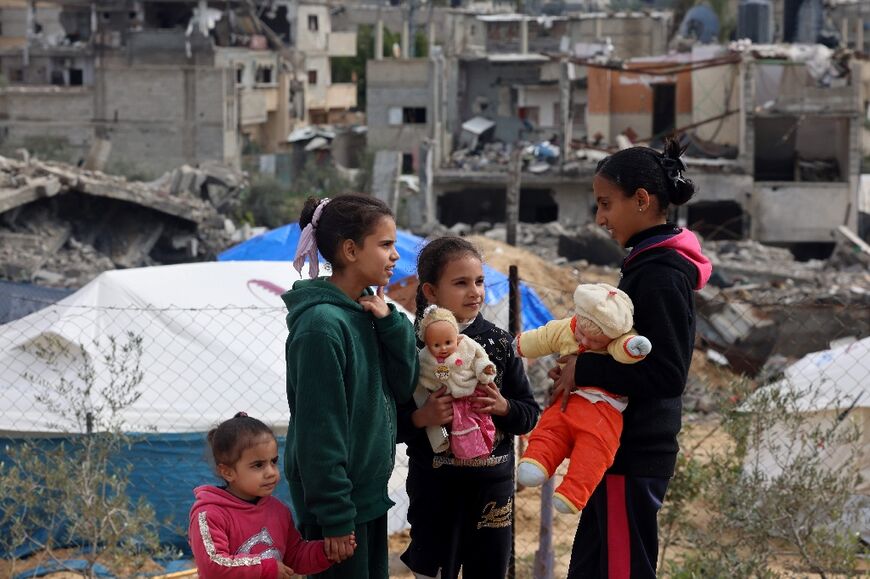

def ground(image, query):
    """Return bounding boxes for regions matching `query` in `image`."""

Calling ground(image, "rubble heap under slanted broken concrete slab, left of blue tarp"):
[0,154,245,288]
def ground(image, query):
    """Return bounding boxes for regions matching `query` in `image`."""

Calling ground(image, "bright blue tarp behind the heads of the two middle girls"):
[218,223,553,330]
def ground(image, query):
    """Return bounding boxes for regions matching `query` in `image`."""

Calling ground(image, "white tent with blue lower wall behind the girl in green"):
[0,261,409,555]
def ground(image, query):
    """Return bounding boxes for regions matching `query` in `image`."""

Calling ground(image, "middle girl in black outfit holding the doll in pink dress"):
[398,237,540,579]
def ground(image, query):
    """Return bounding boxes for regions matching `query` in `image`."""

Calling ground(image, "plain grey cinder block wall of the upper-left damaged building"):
[0,66,238,177]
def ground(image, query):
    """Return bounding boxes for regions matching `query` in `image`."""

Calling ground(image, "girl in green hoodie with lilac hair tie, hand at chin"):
[283,195,418,579]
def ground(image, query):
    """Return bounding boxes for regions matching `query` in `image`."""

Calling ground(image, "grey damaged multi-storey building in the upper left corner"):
[0,0,356,176]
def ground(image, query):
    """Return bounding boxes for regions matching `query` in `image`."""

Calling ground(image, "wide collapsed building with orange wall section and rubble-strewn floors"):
[367,5,866,257]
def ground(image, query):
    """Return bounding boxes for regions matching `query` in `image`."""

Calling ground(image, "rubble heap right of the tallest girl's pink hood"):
[698,239,870,376]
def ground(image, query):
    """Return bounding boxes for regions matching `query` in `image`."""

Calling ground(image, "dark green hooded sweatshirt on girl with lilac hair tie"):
[282,278,418,537]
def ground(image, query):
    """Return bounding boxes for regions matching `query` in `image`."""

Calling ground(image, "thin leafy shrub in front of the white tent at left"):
[0,333,159,577]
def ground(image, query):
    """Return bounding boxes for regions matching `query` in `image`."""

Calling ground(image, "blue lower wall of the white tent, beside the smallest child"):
[0,433,291,558]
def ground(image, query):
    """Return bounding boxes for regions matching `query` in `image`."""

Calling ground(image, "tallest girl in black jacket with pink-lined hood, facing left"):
[552,141,712,579]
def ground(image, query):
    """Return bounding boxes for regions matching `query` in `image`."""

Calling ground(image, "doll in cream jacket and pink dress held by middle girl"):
[414,306,495,459]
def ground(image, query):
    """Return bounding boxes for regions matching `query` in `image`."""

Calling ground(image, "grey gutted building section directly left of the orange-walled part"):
[366,10,671,230]
